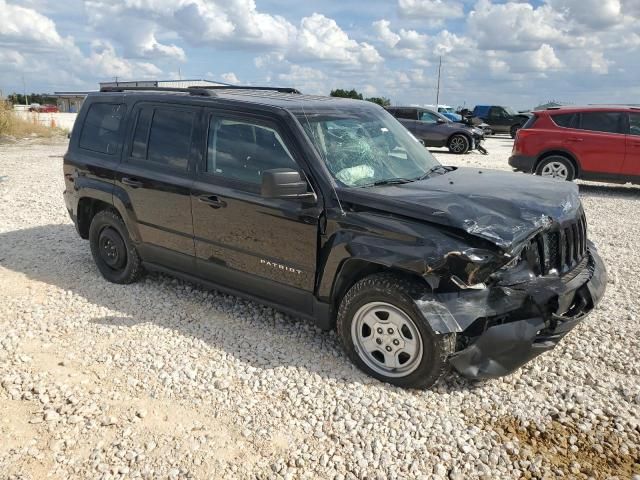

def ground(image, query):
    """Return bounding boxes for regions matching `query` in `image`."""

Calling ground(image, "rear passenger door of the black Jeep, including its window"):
[116,103,200,270]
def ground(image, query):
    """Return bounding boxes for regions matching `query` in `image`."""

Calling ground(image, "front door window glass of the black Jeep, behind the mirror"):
[206,116,297,185]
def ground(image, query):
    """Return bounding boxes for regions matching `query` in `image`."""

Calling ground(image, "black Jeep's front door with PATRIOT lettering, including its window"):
[191,111,322,313]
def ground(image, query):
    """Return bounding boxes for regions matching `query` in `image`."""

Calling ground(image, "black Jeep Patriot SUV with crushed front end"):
[64,87,606,387]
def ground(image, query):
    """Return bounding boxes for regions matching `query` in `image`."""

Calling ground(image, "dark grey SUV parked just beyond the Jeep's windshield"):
[387,107,484,154]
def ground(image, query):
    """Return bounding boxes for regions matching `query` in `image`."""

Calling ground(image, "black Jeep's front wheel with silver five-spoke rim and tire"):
[337,273,455,388]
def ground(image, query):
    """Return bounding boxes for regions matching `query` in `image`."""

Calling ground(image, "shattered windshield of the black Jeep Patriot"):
[297,107,439,187]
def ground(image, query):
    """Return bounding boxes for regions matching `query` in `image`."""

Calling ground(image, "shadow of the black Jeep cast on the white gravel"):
[0,224,472,392]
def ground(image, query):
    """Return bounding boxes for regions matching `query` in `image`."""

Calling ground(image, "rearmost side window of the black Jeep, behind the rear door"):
[79,103,126,155]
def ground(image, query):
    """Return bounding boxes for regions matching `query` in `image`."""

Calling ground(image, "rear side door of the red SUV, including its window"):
[564,110,627,176]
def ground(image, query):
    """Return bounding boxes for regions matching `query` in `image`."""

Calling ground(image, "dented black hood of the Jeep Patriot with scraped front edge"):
[339,168,580,251]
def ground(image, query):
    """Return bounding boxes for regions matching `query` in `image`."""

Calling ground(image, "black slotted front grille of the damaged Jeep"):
[522,210,587,275]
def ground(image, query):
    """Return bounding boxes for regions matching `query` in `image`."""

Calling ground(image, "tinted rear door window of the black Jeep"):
[131,107,194,171]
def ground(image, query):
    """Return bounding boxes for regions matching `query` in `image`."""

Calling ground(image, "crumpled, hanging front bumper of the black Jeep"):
[416,242,607,378]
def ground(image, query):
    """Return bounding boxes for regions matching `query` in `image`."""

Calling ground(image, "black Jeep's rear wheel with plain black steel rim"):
[89,210,143,284]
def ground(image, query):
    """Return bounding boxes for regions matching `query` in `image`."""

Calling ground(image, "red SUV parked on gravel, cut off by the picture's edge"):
[509,106,640,184]
